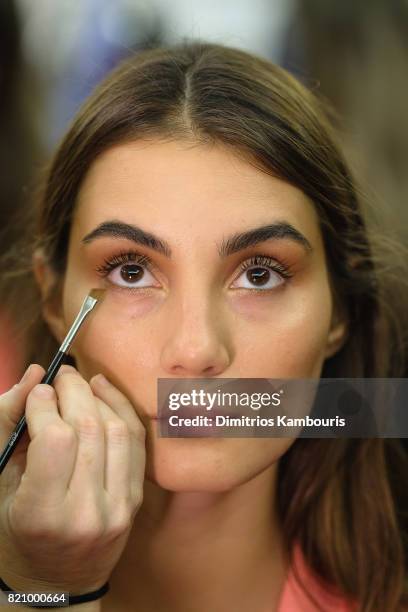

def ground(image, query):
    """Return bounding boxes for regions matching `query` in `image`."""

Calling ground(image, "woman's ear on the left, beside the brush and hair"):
[32,249,66,343]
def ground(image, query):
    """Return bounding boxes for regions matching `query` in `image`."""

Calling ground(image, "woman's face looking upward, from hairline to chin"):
[42,140,344,491]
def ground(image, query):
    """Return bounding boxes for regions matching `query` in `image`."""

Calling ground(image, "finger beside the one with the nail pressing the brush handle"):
[54,365,105,492]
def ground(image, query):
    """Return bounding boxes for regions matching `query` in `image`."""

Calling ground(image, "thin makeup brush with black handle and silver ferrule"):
[0,289,106,474]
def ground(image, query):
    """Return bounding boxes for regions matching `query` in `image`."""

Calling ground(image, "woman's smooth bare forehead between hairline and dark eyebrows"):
[74,141,319,247]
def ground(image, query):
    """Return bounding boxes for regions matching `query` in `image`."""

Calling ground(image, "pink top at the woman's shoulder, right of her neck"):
[277,546,357,612]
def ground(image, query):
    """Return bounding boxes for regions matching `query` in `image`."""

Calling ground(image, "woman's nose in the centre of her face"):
[161,297,232,378]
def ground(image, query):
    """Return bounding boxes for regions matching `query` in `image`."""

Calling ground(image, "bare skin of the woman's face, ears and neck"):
[34,141,345,612]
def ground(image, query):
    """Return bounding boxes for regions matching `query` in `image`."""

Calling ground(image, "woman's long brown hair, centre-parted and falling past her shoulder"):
[2,41,408,612]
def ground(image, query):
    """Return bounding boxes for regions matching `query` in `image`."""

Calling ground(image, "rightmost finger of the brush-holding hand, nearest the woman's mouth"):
[89,376,146,500]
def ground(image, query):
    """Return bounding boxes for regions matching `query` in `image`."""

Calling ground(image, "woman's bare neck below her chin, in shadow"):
[110,464,286,612]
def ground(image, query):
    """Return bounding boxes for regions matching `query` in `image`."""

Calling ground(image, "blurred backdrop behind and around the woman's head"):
[0,0,408,393]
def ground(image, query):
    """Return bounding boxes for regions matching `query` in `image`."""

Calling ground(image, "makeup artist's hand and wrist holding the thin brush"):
[0,364,146,594]
